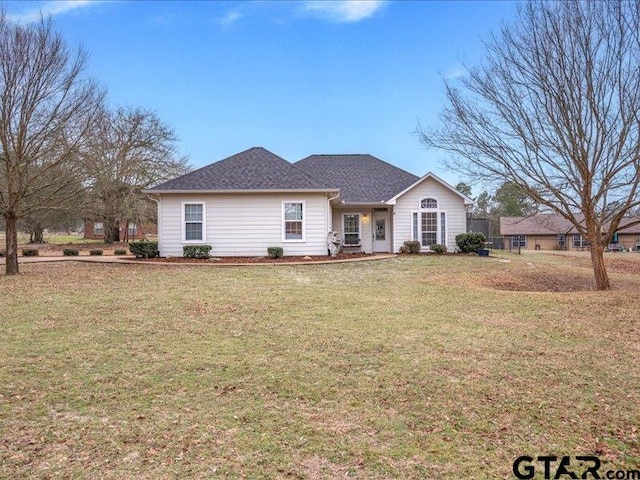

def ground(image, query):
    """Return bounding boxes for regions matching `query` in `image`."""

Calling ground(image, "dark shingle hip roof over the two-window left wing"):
[149,147,335,192]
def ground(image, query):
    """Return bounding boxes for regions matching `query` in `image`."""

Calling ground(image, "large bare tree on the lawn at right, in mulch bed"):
[419,0,640,290]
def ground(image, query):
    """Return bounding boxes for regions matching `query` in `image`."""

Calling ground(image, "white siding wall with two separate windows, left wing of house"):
[158,193,329,257]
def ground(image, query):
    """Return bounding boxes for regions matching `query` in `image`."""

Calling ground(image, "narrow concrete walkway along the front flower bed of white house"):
[0,253,397,267]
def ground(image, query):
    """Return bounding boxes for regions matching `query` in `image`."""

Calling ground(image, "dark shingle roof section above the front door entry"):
[294,155,419,203]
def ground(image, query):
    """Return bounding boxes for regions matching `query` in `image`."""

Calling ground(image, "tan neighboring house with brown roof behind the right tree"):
[500,213,640,251]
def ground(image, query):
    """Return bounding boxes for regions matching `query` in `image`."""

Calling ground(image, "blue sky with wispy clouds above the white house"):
[3,1,517,188]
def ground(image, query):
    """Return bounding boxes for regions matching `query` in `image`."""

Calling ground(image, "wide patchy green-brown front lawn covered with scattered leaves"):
[0,253,640,480]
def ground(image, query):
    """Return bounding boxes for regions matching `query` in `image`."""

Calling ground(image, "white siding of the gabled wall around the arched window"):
[393,178,467,252]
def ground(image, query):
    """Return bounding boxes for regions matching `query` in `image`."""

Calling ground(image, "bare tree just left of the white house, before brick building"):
[82,108,189,243]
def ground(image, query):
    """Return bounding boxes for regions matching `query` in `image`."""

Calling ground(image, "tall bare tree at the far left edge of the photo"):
[0,9,103,275]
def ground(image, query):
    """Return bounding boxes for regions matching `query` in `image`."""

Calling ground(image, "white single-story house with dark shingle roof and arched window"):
[146,147,472,256]
